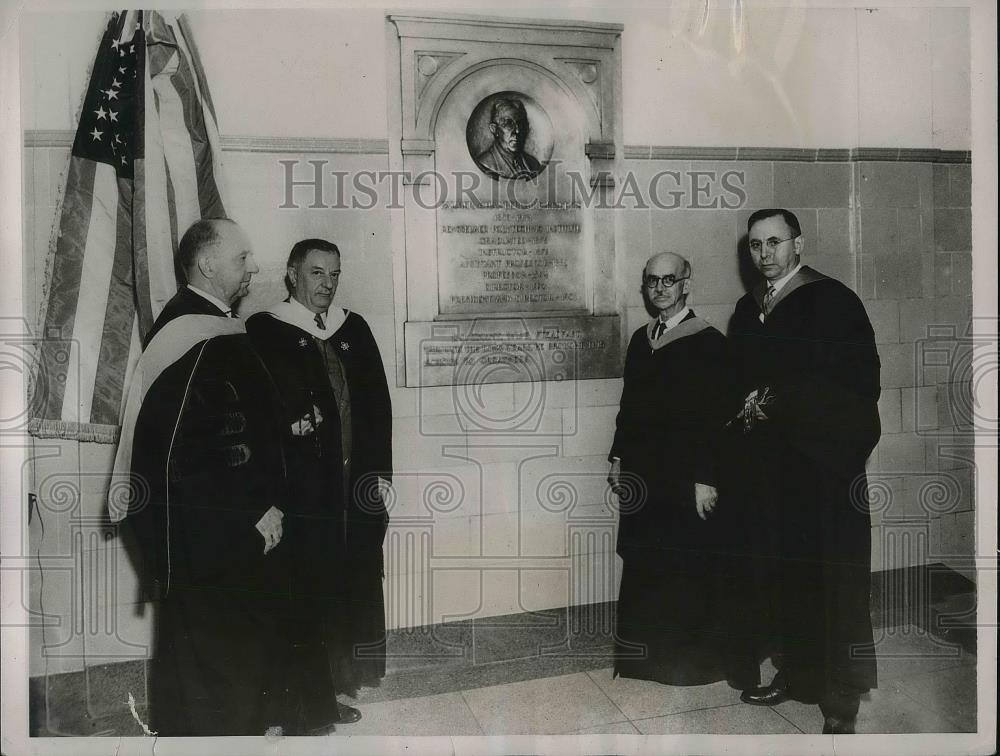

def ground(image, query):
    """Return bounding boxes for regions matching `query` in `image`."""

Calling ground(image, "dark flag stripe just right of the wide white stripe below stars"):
[90,178,135,425]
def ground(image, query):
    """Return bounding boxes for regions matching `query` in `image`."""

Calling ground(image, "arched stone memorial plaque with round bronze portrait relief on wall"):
[388,15,624,386]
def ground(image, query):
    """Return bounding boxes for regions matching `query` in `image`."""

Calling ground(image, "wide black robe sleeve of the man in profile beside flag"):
[129,335,286,588]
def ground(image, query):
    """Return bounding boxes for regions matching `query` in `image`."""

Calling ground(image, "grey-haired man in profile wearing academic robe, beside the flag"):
[109,219,288,736]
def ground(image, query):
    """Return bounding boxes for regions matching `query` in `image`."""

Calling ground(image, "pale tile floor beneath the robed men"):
[331,626,976,737]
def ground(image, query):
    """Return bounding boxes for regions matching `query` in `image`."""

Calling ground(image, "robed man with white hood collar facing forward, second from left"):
[247,239,392,732]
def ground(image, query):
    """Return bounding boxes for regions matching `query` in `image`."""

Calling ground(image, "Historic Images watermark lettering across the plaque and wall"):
[278,159,748,210]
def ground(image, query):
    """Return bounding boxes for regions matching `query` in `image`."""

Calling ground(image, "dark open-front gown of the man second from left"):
[247,305,392,695]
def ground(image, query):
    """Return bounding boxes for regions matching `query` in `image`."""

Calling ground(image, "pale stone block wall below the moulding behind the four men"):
[22,133,974,675]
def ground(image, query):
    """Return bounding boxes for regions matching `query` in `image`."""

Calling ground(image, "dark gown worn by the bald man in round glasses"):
[610,313,758,687]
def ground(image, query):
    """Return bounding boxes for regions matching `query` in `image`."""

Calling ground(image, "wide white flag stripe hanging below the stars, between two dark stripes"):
[62,163,118,423]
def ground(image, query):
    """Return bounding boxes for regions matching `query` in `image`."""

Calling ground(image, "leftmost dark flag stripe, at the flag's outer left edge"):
[33,157,97,420]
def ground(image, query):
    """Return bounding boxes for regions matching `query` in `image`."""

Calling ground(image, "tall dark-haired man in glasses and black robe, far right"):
[731,209,880,733]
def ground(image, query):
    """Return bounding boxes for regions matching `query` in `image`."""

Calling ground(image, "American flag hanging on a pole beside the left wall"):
[29,11,225,443]
